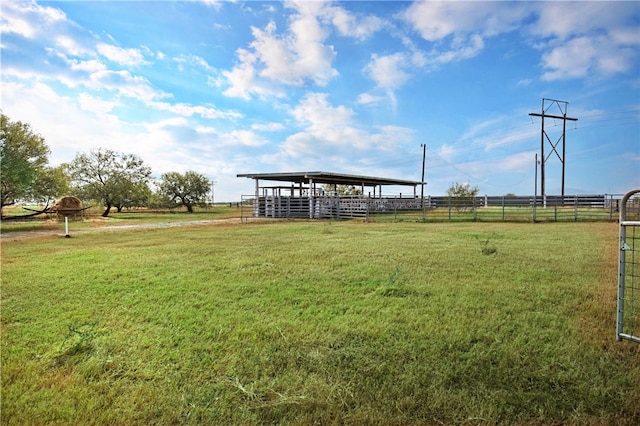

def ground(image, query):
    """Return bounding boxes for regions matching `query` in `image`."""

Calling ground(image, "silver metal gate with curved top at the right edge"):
[616,188,640,343]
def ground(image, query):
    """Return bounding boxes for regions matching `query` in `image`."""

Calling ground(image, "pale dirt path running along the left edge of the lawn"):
[0,218,242,241]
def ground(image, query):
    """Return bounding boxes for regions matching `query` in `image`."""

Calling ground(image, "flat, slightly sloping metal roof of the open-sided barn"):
[237,172,422,186]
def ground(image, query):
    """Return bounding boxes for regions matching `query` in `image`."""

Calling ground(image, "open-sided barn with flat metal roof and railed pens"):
[237,172,422,219]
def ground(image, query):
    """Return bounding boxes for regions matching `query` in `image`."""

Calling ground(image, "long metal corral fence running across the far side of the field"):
[241,194,640,222]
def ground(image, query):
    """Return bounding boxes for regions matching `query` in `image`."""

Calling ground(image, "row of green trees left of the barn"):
[0,112,210,217]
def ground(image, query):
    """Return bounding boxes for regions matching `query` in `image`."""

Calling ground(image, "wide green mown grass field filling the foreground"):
[0,219,640,425]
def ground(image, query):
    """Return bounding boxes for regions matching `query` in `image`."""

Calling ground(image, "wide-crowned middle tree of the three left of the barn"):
[66,148,151,217]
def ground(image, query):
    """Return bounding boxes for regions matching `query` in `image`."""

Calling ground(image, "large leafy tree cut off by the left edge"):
[0,113,49,212]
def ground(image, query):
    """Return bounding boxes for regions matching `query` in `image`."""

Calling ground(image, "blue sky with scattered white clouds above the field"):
[0,1,640,201]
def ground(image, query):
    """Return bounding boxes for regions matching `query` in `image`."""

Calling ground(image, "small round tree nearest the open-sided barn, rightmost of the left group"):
[159,171,211,213]
